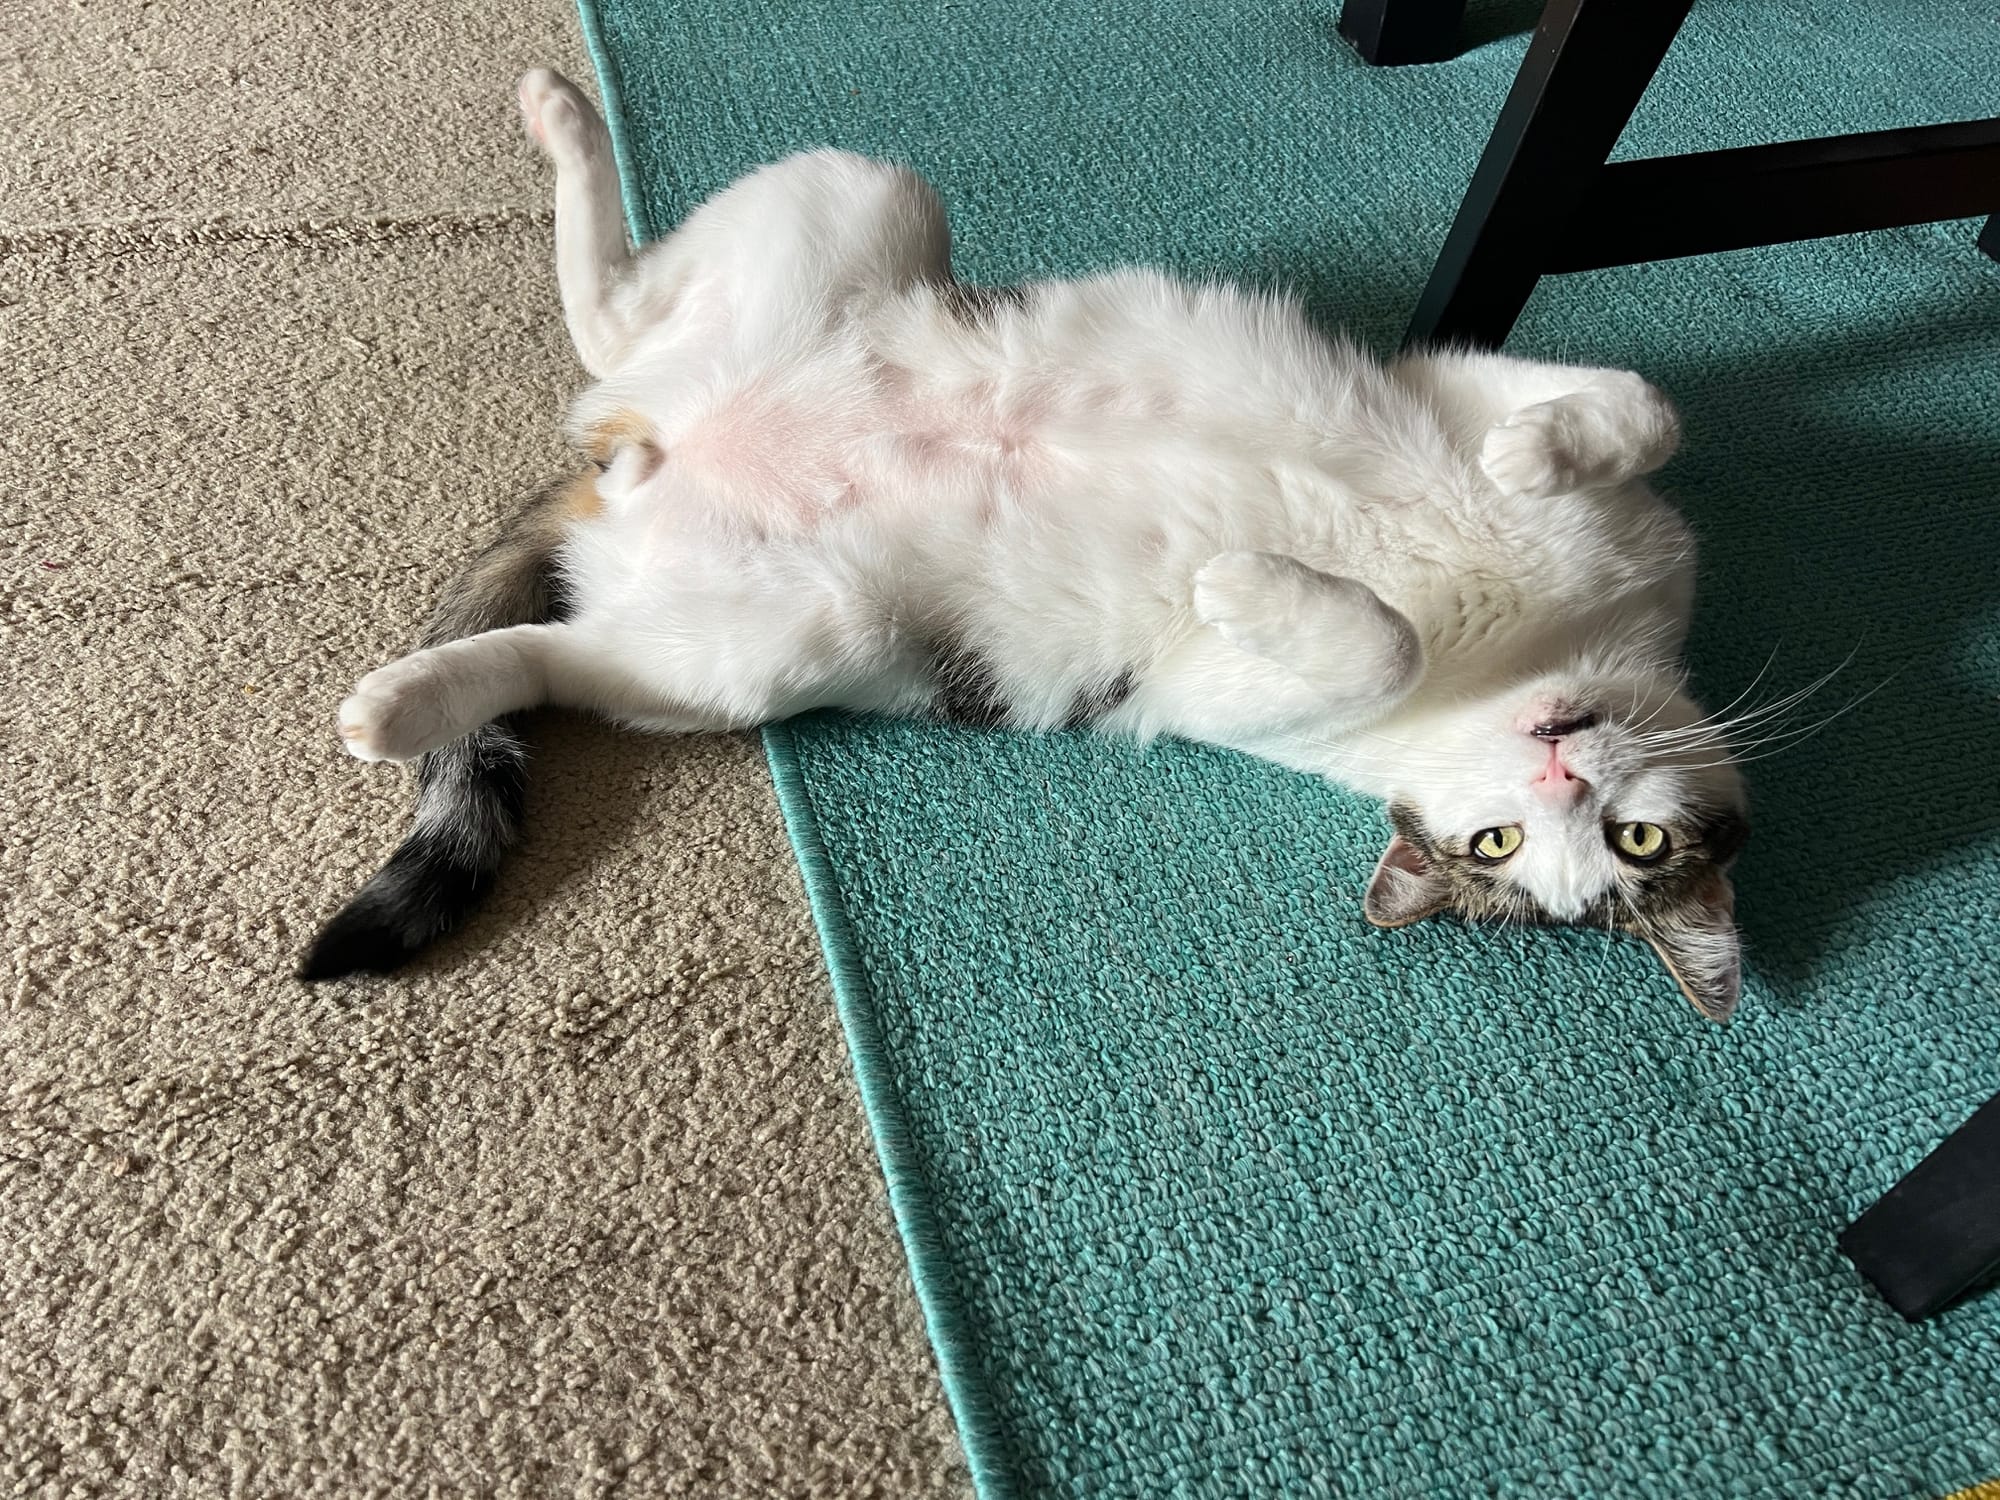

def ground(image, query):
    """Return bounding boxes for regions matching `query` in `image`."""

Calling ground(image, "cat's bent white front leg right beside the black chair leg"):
[1390,352,1680,496]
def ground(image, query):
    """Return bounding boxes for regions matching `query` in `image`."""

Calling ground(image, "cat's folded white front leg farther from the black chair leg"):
[1162,552,1424,744]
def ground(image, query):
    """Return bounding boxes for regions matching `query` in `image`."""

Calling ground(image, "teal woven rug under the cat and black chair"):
[584,0,2000,1500]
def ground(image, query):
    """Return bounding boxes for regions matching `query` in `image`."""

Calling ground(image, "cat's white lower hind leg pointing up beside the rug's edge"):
[518,68,632,376]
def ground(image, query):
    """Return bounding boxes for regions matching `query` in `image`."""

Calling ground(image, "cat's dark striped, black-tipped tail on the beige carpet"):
[298,478,596,980]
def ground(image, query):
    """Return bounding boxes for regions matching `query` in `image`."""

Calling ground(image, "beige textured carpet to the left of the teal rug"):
[0,0,966,1496]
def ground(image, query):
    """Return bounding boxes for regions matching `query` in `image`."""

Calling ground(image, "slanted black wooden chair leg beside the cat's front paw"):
[1404,0,1694,348]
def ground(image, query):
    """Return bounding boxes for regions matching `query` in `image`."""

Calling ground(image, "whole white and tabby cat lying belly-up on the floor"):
[300,70,1748,1020]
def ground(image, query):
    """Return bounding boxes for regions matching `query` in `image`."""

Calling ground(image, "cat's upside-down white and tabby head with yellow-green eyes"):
[1364,672,1750,1020]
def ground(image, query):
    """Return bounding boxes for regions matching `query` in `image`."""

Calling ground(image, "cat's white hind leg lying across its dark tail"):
[340,624,758,760]
